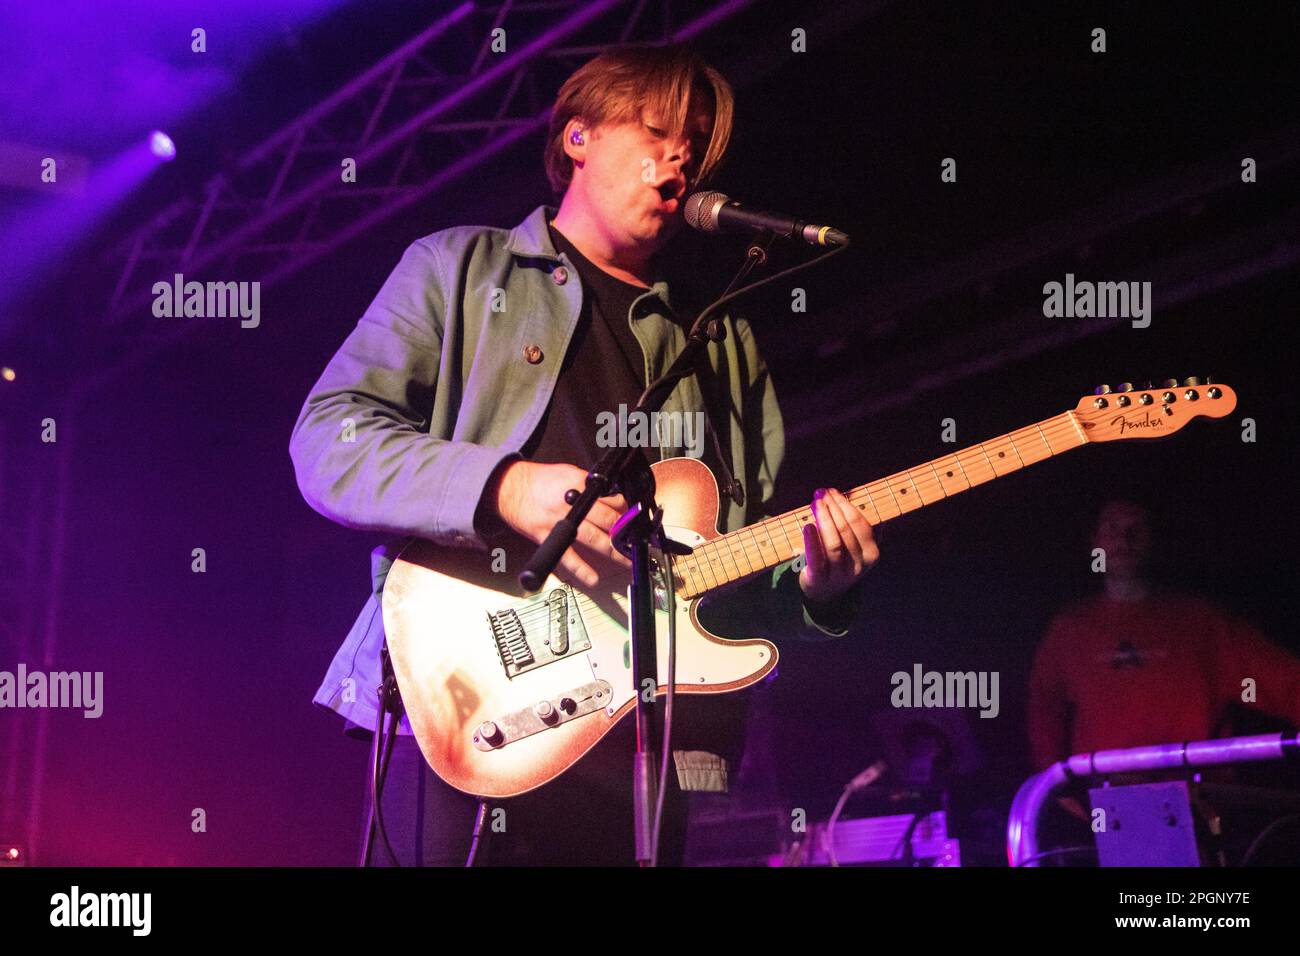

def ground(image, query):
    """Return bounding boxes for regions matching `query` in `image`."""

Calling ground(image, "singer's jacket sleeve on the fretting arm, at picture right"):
[701,319,866,643]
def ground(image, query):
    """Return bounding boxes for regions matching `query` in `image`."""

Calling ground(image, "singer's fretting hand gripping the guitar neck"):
[800,488,880,606]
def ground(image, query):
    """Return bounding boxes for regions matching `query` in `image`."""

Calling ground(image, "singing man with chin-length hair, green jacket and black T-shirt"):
[290,46,879,866]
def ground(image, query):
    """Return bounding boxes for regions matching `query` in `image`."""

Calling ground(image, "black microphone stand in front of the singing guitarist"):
[519,230,775,866]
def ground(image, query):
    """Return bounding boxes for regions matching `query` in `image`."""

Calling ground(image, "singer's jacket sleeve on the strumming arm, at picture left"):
[289,239,511,548]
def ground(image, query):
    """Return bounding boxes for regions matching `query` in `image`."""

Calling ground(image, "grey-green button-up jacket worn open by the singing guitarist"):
[290,206,855,790]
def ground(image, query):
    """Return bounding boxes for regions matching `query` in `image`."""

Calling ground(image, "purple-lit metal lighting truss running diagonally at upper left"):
[100,0,750,352]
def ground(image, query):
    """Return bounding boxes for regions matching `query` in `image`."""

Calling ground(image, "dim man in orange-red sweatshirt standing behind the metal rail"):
[1028,501,1300,769]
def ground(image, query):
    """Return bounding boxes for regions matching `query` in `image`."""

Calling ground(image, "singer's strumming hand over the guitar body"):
[484,459,632,589]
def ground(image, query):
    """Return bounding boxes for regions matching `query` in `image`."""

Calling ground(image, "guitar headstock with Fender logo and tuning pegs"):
[1074,378,1236,441]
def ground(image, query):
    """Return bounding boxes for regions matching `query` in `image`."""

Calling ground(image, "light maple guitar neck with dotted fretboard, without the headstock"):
[673,411,1088,600]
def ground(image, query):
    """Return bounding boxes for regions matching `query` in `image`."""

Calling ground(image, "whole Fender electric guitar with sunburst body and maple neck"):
[384,378,1236,797]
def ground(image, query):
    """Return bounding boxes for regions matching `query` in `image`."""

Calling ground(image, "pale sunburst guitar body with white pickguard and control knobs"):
[384,458,777,797]
